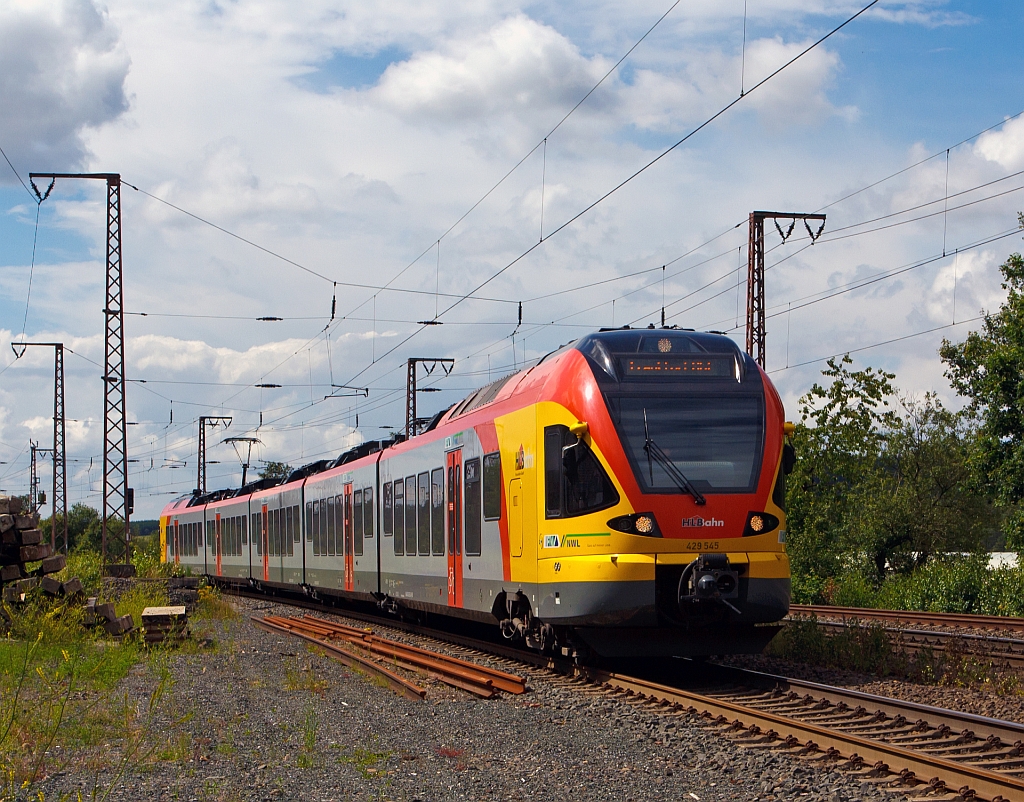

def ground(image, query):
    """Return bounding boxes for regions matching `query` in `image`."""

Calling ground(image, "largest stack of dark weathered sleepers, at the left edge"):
[0,496,74,602]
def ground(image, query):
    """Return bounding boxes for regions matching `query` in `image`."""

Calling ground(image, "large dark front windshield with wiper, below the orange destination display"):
[607,394,764,493]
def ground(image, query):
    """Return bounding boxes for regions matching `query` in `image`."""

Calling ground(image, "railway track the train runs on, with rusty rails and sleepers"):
[218,590,1024,802]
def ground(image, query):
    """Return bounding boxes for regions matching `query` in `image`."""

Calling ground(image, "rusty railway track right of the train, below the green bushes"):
[790,604,1024,668]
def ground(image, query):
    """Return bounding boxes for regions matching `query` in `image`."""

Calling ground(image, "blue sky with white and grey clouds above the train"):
[0,0,1024,517]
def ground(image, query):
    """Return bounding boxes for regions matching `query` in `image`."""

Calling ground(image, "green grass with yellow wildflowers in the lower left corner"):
[0,569,197,800]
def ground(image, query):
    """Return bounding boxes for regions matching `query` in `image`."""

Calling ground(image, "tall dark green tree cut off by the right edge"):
[939,241,1024,551]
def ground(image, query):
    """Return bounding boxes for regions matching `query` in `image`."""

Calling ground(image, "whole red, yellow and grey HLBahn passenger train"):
[161,329,793,657]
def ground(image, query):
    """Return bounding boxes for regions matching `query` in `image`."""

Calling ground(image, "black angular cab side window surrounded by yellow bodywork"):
[544,426,618,518]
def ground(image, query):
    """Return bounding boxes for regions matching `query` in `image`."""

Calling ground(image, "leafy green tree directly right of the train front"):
[786,356,995,601]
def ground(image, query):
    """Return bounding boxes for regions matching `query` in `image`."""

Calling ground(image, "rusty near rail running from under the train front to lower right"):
[586,669,1024,802]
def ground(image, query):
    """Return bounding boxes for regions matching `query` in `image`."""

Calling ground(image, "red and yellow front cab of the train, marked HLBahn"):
[516,331,790,657]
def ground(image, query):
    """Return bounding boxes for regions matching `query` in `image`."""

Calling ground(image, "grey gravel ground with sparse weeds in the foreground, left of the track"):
[30,599,892,802]
